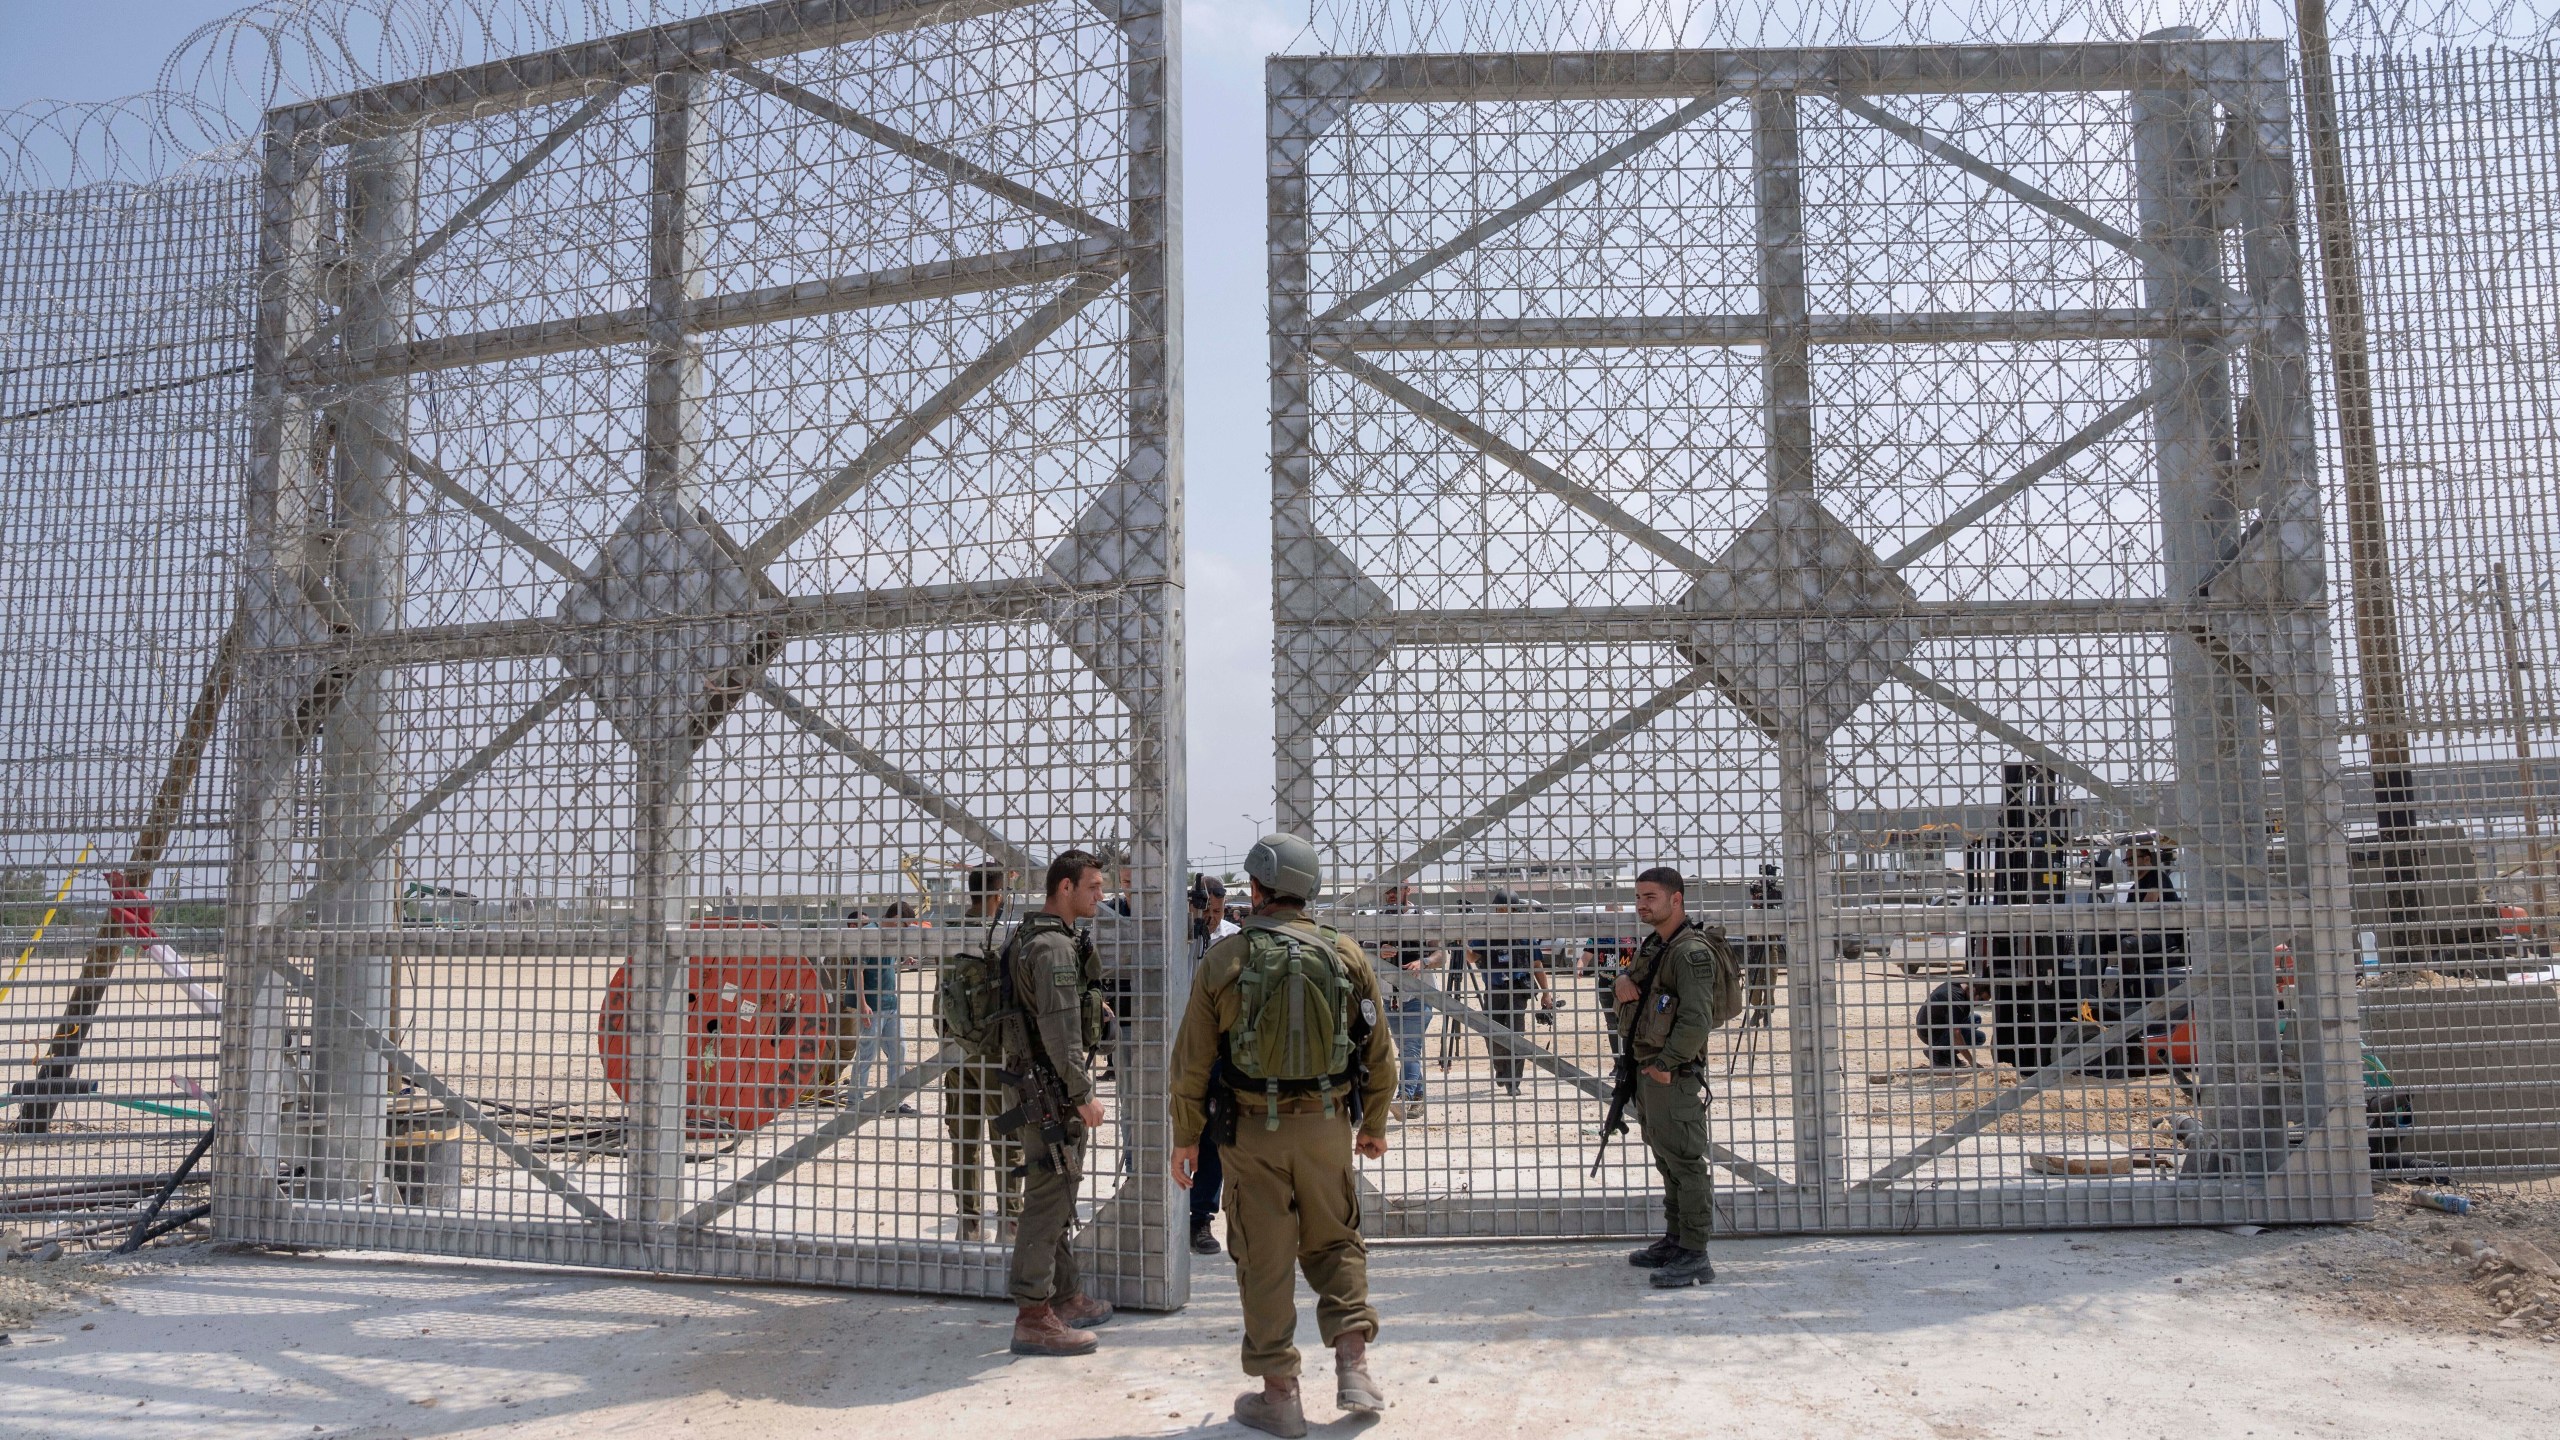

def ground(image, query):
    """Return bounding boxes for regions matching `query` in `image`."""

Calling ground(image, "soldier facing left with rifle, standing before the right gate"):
[1615,866,1715,1289]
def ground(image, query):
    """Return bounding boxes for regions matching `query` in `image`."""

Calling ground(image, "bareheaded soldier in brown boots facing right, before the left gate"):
[1004,851,1111,1355]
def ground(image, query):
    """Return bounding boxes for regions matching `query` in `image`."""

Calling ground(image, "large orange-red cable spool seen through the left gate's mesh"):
[596,920,835,1138]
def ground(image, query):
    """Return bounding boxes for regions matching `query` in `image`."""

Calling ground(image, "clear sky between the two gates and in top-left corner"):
[0,0,1306,853]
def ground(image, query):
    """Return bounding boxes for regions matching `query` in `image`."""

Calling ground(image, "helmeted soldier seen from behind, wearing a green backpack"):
[1170,835,1395,1435]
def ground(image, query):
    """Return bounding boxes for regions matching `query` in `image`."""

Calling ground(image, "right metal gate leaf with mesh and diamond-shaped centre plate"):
[1270,33,2371,1235]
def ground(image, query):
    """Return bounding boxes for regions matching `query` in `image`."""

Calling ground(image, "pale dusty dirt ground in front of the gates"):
[0,1186,2560,1440]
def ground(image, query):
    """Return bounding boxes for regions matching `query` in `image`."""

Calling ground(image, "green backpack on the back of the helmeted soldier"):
[1226,917,1352,1130]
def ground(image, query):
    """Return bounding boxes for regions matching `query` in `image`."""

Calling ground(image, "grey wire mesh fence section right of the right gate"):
[2335,51,2560,1181]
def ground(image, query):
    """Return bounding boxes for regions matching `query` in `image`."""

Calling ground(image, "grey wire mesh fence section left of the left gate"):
[0,179,253,1238]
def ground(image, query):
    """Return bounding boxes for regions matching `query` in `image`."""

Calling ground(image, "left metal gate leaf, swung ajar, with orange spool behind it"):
[218,0,1188,1307]
